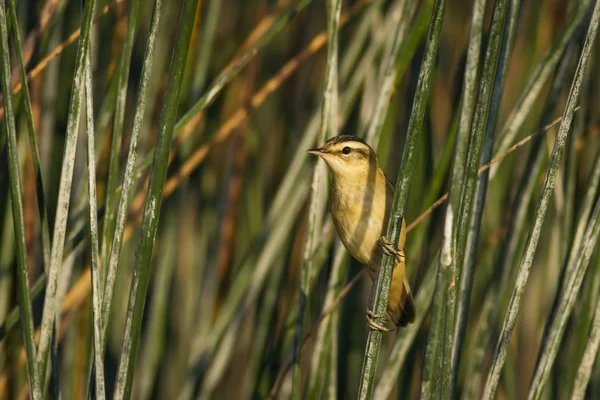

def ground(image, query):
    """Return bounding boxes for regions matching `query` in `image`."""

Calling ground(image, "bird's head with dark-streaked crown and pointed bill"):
[307,135,377,176]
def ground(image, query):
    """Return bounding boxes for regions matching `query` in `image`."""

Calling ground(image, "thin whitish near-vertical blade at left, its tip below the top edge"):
[85,52,106,400]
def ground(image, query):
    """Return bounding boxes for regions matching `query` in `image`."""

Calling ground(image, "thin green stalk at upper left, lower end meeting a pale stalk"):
[8,0,50,269]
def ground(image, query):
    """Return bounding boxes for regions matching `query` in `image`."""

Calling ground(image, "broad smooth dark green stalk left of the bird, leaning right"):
[114,0,198,399]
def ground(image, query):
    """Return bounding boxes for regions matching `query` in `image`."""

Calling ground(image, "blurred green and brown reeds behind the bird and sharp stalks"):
[0,0,600,399]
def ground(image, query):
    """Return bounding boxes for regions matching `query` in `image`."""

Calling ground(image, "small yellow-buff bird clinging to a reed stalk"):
[307,135,415,331]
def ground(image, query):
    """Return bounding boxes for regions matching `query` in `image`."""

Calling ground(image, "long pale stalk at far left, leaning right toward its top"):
[37,0,96,390]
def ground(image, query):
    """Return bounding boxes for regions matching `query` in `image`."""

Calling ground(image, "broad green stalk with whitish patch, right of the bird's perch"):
[421,0,509,398]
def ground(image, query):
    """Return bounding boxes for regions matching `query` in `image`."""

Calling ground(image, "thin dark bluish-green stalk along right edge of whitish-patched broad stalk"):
[450,0,521,394]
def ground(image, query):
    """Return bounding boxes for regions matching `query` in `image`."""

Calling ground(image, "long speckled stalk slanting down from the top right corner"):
[484,1,600,399]
